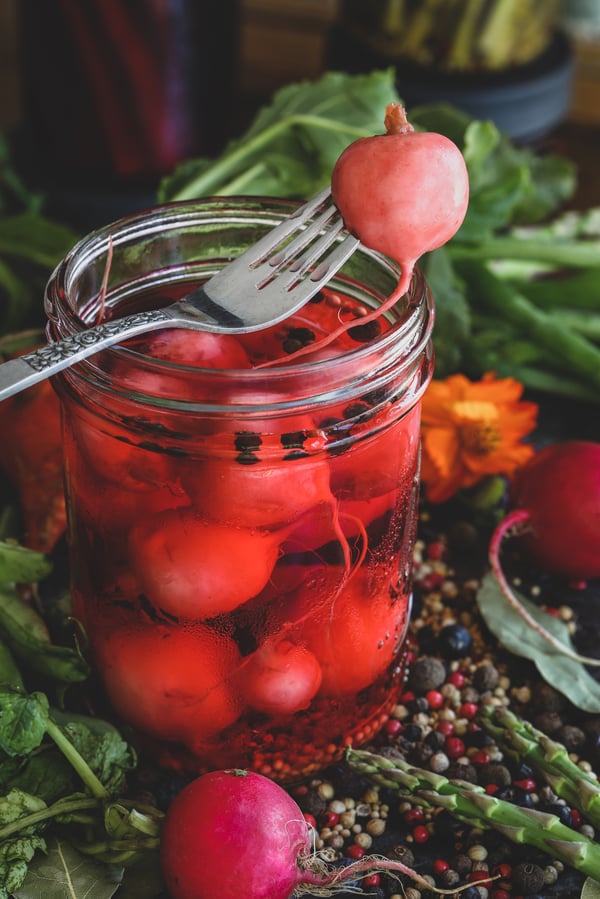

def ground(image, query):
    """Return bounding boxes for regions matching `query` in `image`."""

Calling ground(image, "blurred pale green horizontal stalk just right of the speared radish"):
[447,235,600,269]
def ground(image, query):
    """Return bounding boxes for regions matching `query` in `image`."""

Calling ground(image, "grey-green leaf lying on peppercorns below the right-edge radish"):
[477,574,600,714]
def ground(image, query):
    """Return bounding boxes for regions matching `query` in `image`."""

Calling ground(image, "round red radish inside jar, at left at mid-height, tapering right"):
[129,508,285,619]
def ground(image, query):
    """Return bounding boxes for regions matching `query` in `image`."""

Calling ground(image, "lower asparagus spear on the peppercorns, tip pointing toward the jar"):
[346,749,600,880]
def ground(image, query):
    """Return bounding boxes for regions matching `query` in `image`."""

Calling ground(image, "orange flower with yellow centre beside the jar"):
[421,372,538,503]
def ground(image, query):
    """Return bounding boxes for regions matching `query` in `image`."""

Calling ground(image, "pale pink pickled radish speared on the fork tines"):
[331,103,469,297]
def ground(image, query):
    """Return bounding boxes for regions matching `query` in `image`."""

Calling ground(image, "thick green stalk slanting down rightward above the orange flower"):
[456,262,600,396]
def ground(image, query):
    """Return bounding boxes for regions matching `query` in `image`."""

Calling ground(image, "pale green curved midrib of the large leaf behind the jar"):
[171,115,365,201]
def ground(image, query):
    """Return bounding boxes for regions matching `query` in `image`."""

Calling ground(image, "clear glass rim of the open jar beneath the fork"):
[45,196,434,408]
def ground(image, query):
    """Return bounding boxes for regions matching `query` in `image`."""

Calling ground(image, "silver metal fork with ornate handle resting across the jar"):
[0,188,359,400]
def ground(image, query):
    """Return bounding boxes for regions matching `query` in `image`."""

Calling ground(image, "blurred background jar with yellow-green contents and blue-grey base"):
[327,0,573,143]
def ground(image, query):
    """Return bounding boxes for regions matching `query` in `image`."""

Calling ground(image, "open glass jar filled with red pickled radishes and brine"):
[46,198,433,781]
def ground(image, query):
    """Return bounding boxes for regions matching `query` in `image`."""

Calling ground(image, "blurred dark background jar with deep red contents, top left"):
[18,0,239,227]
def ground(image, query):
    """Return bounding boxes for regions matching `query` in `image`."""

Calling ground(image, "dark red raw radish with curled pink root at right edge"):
[489,440,600,665]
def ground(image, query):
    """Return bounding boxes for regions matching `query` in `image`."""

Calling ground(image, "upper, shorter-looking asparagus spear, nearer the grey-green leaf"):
[481,707,600,828]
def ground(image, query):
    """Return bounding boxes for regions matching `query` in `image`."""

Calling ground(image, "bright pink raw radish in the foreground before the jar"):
[161,769,440,899]
